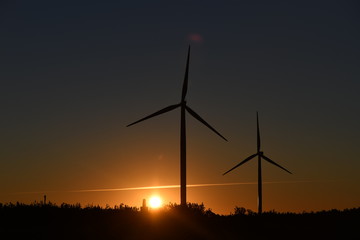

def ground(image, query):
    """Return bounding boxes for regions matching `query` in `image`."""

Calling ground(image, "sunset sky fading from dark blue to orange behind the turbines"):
[0,0,360,214]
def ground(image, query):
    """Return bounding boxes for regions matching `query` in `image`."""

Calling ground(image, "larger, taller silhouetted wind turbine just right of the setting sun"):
[127,46,227,206]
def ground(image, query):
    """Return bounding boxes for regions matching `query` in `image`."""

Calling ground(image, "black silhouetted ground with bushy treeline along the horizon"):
[0,204,360,240]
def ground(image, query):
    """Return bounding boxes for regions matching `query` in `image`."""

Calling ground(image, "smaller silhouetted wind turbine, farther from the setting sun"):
[223,112,292,214]
